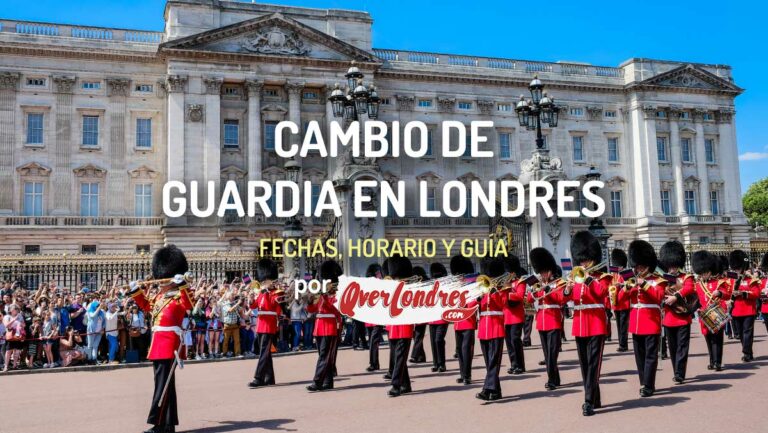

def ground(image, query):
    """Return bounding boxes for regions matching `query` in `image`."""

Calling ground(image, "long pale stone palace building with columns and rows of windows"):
[0,0,749,276]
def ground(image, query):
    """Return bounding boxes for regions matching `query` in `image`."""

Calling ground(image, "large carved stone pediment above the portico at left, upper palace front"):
[160,13,380,63]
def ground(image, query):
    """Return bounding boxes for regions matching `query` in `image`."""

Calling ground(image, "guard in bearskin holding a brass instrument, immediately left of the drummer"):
[659,241,696,384]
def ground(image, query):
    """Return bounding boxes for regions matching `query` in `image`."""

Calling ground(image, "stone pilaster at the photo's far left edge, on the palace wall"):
[0,72,21,215]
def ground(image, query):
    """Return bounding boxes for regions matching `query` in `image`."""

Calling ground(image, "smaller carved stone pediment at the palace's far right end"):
[632,64,743,95]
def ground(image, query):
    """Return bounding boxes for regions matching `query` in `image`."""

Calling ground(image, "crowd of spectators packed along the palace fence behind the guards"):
[0,275,368,371]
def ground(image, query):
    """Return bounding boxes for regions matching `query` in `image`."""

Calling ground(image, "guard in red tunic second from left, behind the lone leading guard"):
[248,259,282,388]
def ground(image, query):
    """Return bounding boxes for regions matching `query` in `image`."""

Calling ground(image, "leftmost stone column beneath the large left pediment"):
[165,75,187,182]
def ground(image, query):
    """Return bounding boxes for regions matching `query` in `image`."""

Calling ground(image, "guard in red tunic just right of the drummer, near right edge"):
[728,250,760,362]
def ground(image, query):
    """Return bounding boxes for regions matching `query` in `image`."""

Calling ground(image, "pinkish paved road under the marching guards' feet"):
[0,322,768,433]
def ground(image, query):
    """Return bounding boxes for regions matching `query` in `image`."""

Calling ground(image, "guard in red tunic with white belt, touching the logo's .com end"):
[475,258,508,401]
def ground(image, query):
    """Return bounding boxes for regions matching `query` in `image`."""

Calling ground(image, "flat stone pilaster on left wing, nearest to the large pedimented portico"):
[102,78,133,216]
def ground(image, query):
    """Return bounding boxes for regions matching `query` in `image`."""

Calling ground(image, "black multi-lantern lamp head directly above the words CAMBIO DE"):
[328,63,381,122]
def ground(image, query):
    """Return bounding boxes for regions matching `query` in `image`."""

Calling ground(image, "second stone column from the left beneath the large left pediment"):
[202,77,224,209]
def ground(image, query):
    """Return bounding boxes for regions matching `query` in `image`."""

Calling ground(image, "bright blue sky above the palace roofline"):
[0,0,768,191]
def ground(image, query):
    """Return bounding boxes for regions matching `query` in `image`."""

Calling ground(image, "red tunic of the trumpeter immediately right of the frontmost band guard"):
[628,274,667,335]
